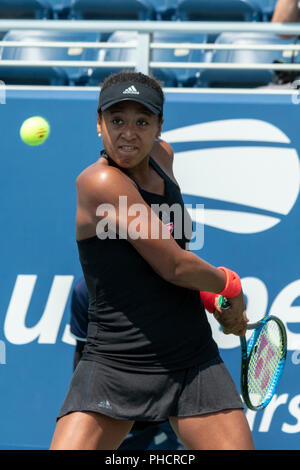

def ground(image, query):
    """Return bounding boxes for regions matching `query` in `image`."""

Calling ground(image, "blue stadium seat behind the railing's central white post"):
[89,32,206,87]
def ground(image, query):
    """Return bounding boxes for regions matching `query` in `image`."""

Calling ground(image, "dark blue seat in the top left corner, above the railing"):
[0,0,51,20]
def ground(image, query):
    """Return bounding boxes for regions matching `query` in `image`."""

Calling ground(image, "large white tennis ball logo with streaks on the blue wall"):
[162,119,300,234]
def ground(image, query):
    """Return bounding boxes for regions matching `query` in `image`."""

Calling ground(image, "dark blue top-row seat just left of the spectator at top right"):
[176,0,262,21]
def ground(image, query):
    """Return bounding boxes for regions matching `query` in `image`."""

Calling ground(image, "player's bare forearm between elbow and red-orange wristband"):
[169,251,226,293]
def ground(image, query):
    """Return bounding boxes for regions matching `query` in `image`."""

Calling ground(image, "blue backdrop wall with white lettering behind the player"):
[0,89,300,449]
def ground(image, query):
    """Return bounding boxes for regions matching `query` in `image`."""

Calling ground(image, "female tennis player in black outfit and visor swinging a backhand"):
[51,72,253,450]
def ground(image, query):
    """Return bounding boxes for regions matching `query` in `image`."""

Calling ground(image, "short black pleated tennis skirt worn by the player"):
[58,357,244,422]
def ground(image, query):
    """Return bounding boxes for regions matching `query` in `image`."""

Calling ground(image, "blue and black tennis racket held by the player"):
[218,296,287,411]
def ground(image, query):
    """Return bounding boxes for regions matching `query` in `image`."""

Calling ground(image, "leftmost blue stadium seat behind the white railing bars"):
[0,30,101,85]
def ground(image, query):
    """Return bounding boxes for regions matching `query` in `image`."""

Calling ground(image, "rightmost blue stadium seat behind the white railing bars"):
[201,33,299,88]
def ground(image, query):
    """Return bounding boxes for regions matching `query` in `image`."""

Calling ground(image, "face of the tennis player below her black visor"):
[98,101,162,168]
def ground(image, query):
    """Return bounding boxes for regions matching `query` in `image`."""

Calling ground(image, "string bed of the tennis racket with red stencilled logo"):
[247,320,284,406]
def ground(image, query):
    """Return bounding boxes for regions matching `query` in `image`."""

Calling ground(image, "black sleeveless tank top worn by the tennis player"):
[77,153,218,372]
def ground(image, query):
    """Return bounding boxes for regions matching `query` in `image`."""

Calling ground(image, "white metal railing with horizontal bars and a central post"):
[0,20,300,78]
